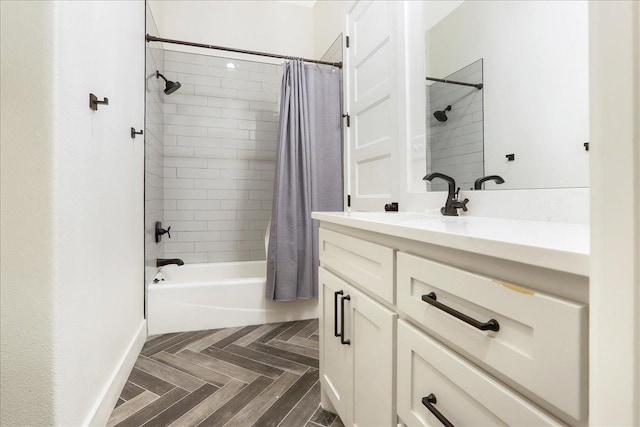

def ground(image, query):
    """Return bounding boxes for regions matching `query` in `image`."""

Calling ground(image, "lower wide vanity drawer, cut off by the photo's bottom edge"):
[398,320,562,427]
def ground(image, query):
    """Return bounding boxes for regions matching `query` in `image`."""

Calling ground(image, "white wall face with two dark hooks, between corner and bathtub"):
[53,1,145,425]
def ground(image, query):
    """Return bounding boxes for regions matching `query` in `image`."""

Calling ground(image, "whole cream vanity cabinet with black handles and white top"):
[314,213,588,427]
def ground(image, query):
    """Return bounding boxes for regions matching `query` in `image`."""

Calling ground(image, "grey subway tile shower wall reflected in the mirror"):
[427,59,484,191]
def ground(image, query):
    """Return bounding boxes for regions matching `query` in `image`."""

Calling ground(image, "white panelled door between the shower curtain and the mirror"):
[346,1,402,210]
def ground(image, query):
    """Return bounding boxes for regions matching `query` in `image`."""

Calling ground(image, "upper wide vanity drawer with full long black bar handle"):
[397,253,588,421]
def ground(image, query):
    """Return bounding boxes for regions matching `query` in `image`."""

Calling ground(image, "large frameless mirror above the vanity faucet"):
[425,1,589,191]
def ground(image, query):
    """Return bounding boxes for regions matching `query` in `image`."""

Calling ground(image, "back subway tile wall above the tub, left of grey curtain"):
[163,51,282,263]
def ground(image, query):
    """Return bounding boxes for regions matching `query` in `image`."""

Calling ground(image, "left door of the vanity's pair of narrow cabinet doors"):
[318,267,352,420]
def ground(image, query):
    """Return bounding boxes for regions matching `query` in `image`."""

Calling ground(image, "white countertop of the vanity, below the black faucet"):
[312,212,589,276]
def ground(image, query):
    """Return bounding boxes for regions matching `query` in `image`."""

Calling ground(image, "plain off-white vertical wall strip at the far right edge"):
[589,2,640,426]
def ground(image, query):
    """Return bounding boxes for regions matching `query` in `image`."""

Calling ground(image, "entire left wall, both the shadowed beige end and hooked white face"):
[1,1,144,426]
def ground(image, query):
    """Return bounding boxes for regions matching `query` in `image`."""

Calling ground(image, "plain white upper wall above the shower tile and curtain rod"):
[150,0,316,64]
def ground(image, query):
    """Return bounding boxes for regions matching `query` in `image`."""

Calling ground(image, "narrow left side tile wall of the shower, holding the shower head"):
[145,5,164,284]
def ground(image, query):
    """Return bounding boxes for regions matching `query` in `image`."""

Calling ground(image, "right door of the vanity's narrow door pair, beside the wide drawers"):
[345,284,397,427]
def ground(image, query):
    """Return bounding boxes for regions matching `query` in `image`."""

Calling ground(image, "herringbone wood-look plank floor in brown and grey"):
[107,319,343,427]
